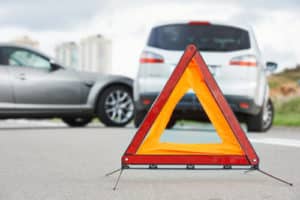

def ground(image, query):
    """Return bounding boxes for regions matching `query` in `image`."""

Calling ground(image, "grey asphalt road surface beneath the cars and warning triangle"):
[0,120,300,200]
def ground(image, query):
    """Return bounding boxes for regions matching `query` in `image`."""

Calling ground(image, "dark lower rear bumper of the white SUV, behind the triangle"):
[135,93,261,120]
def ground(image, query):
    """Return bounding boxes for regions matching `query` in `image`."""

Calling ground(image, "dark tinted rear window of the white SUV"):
[148,24,250,51]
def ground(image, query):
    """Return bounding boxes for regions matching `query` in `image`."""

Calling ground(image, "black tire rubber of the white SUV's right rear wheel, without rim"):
[247,99,274,132]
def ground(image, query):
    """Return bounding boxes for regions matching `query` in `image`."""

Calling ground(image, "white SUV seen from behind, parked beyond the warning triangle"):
[134,21,277,131]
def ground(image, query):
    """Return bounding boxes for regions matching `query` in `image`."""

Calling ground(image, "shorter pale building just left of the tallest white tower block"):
[55,42,79,68]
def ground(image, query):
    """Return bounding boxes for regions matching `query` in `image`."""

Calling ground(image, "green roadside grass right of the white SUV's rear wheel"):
[274,97,300,126]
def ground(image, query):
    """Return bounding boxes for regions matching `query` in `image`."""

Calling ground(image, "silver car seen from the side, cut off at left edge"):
[0,44,134,127]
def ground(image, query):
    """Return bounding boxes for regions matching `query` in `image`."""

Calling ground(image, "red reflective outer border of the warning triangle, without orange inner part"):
[121,45,259,166]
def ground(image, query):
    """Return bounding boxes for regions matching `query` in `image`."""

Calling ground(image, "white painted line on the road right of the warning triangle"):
[249,138,300,148]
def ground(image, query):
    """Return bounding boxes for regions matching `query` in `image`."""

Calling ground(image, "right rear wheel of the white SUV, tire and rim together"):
[247,99,274,132]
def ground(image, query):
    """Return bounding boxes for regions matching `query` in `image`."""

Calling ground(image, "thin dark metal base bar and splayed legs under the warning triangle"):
[105,165,293,191]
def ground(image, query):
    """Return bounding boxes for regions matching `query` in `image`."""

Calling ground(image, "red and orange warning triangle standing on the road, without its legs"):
[122,45,259,167]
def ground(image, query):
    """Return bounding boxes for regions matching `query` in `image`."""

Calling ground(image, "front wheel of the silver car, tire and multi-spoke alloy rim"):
[97,86,134,127]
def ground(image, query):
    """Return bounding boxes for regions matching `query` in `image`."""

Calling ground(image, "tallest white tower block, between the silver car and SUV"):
[79,35,112,73]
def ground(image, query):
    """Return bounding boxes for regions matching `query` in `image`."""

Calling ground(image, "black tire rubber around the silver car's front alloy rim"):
[96,85,134,127]
